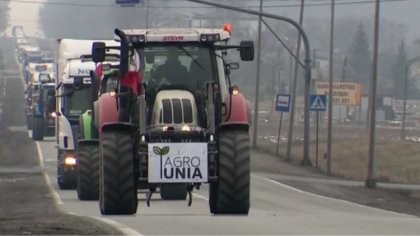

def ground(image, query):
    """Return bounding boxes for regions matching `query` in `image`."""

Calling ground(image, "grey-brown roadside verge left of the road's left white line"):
[0,38,120,235]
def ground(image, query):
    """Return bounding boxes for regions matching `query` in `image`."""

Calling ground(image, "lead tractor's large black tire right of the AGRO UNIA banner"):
[209,129,250,215]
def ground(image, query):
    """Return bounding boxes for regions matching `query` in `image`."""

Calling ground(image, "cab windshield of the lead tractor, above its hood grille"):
[138,44,216,91]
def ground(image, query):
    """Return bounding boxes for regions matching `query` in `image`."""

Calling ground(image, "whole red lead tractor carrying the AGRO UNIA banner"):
[92,27,254,215]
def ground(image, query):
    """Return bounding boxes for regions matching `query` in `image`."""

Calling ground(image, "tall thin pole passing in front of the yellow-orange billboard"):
[327,0,335,175]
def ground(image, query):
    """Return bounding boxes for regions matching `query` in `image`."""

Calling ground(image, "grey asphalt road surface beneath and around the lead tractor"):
[38,136,420,235]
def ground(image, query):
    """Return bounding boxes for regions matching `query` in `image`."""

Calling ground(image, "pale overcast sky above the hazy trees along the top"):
[8,0,420,41]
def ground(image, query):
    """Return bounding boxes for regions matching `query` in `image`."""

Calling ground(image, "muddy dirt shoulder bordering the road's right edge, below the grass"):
[251,149,420,216]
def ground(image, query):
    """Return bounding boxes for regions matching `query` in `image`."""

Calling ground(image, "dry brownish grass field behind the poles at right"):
[260,135,420,184]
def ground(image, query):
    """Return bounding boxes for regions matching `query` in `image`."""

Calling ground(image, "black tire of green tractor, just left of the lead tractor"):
[77,143,99,201]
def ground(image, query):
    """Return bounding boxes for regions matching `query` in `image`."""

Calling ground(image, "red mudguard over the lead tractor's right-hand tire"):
[222,93,251,128]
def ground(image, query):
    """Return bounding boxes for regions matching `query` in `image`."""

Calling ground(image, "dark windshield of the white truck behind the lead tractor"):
[63,85,92,116]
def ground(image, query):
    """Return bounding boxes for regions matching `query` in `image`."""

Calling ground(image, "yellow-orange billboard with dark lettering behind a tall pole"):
[316,82,362,105]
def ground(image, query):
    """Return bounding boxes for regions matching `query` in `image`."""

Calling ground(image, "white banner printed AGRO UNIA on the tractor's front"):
[148,143,208,183]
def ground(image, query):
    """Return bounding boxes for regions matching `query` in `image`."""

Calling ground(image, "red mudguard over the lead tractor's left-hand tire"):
[98,93,118,134]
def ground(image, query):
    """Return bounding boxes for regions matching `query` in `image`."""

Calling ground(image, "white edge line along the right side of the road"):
[252,174,413,217]
